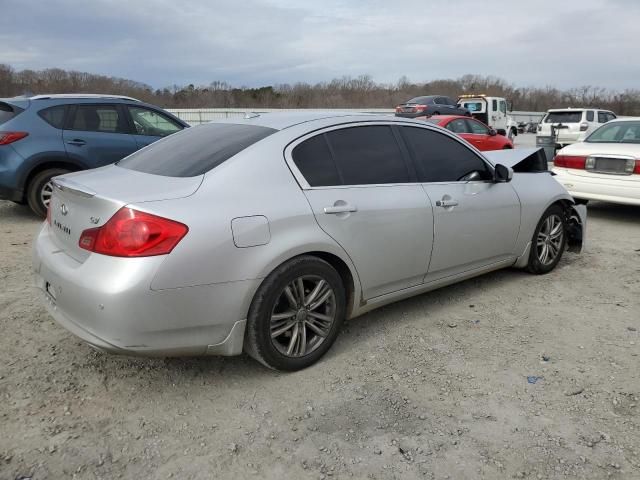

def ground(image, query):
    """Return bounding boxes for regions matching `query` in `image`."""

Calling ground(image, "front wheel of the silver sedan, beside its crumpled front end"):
[527,205,567,275]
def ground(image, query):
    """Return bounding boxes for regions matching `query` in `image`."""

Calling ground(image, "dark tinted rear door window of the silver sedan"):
[326,125,409,185]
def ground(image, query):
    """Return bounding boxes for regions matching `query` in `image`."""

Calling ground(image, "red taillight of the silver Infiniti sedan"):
[78,207,189,257]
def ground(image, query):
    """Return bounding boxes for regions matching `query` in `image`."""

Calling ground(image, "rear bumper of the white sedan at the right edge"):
[553,167,640,205]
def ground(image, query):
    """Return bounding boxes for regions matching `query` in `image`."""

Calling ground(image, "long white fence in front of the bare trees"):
[167,108,544,125]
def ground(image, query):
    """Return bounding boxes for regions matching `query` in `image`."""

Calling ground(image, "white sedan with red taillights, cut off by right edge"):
[553,118,640,205]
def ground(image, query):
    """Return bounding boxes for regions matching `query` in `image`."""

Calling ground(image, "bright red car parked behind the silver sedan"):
[416,115,513,151]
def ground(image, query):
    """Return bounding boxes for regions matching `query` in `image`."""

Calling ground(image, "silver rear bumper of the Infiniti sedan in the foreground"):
[33,224,258,356]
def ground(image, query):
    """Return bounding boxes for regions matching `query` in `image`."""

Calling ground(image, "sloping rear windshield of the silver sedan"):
[117,123,277,177]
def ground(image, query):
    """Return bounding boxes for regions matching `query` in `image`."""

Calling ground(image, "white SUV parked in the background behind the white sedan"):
[538,108,616,148]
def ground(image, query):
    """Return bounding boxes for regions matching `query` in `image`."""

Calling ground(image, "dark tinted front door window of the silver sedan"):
[401,127,491,182]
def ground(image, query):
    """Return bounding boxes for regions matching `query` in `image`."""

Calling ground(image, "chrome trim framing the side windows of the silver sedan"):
[283,120,495,190]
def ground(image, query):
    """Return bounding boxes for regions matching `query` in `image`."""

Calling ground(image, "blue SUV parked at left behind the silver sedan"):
[0,94,189,217]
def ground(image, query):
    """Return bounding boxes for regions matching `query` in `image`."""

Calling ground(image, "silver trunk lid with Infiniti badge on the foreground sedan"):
[50,165,204,262]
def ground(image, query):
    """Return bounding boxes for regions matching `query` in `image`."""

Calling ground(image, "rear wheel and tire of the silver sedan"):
[244,255,346,371]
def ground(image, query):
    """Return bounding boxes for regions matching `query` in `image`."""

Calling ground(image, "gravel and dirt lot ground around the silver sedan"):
[0,196,640,479]
